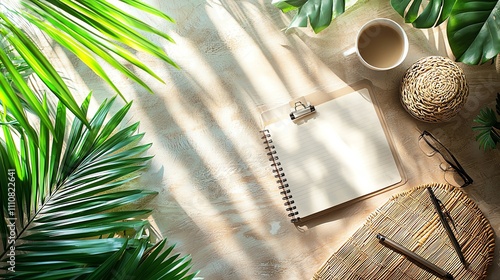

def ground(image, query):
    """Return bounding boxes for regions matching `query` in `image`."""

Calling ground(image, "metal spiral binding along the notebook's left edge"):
[261,129,299,223]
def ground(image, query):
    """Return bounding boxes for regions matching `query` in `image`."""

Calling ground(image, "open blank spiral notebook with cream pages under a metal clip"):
[262,81,404,223]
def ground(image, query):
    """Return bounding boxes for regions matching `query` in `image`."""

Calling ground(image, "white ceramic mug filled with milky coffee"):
[356,18,409,71]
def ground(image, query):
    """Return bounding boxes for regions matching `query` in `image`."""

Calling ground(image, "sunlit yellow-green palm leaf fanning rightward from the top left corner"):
[22,0,178,94]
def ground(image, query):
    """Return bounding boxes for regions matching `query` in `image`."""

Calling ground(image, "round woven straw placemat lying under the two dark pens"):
[313,184,495,280]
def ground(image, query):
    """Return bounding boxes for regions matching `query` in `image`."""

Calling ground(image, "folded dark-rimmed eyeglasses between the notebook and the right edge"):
[418,130,473,187]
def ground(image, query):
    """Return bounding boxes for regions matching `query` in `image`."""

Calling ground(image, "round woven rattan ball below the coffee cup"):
[401,56,469,123]
